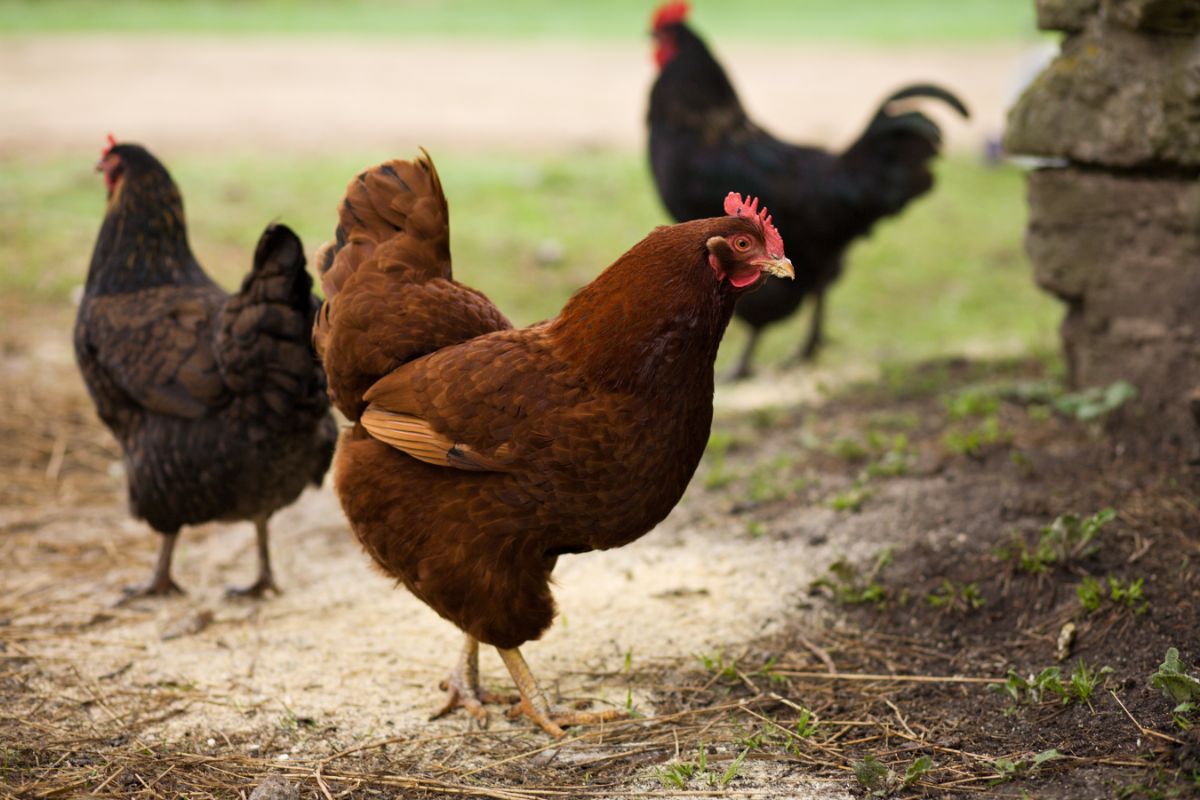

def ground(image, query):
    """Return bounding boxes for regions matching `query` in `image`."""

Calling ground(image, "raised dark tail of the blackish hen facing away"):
[216,224,329,426]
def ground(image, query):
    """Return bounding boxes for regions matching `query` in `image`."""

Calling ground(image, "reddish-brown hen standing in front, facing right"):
[314,149,792,736]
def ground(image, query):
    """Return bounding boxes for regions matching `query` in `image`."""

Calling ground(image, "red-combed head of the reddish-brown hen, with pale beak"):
[704,192,796,291]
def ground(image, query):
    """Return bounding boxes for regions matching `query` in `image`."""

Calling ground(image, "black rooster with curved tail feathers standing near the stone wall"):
[649,2,967,378]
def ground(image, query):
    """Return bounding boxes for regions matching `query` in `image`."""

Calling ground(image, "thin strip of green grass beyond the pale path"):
[0,0,1033,43]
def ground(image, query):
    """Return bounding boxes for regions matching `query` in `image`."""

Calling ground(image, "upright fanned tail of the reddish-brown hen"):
[313,150,511,420]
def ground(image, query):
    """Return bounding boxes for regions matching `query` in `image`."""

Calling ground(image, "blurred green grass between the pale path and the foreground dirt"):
[0,151,1060,368]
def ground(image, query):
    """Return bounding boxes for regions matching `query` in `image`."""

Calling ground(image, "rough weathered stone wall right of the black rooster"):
[1004,0,1200,458]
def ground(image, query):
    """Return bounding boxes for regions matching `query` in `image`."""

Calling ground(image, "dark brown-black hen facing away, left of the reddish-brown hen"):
[74,139,336,595]
